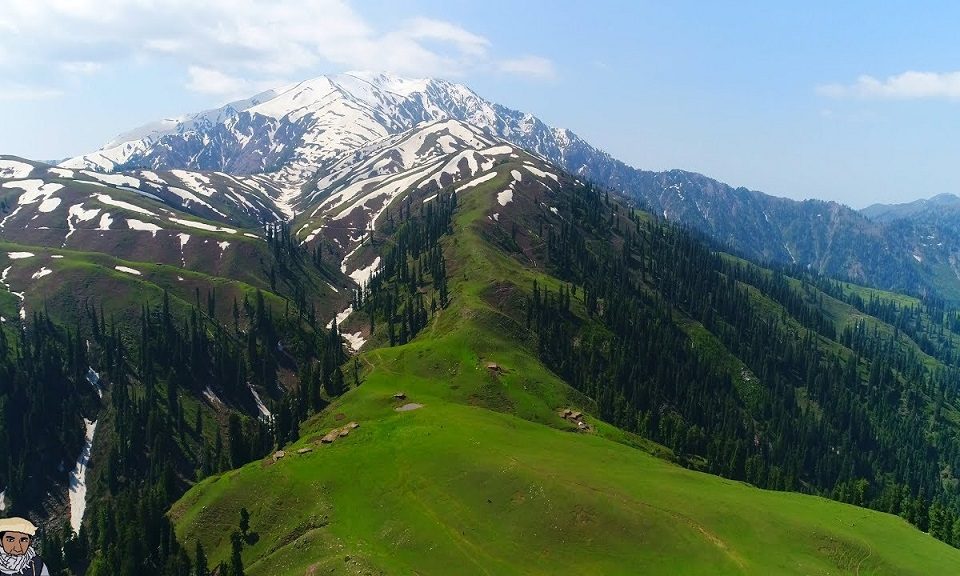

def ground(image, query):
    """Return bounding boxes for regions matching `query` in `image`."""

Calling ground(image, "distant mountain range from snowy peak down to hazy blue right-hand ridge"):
[61,73,960,299]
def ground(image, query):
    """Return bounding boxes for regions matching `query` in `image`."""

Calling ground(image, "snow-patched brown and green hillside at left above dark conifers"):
[0,170,350,332]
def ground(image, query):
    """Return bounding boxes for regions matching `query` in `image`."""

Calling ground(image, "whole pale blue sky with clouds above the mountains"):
[0,0,960,207]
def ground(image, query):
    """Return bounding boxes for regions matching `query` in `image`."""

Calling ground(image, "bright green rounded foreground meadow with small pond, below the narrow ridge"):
[172,372,960,575]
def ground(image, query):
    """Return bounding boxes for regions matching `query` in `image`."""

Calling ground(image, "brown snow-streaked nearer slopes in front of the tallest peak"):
[0,119,575,349]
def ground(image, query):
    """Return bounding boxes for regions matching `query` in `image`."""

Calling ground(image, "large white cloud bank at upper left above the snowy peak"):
[0,0,555,96]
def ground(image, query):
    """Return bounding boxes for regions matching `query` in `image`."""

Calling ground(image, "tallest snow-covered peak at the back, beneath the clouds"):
[60,73,579,190]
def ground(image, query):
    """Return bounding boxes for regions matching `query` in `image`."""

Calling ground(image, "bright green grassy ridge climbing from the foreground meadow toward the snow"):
[170,164,960,576]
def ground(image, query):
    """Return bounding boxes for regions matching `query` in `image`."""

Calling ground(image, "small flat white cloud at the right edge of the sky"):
[817,70,960,100]
